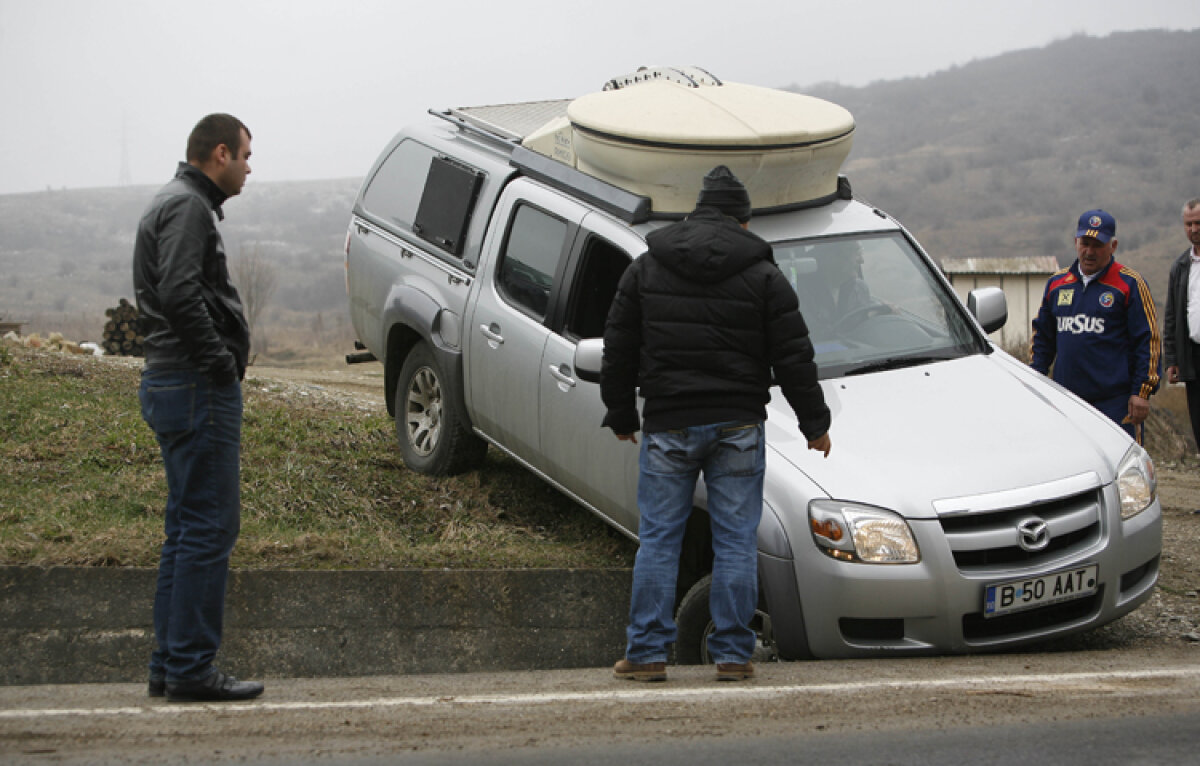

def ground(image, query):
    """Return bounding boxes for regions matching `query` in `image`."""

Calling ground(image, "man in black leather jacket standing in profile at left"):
[133,114,263,701]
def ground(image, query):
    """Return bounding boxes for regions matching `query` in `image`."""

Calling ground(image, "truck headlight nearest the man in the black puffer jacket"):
[809,499,920,564]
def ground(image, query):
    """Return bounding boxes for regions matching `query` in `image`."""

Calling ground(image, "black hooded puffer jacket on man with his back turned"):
[600,208,829,441]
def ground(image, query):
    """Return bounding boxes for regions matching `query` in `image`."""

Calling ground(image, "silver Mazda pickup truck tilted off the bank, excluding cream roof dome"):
[346,81,1162,662]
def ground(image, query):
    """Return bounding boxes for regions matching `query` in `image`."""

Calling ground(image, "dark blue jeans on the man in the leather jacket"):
[138,370,242,682]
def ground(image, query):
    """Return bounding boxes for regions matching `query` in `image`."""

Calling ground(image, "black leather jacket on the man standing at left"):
[133,162,250,384]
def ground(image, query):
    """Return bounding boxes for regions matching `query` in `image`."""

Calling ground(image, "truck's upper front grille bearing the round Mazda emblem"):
[940,490,1102,573]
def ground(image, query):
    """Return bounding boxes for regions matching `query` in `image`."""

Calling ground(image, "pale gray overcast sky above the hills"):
[0,0,1200,193]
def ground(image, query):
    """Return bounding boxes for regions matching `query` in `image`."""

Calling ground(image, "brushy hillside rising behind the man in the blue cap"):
[803,30,1200,290]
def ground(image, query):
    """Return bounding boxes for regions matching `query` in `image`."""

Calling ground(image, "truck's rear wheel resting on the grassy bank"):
[395,343,487,475]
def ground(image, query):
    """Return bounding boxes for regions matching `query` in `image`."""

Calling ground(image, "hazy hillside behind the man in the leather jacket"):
[0,177,361,362]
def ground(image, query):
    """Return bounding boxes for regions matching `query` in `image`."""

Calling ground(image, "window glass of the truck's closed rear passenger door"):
[497,205,568,319]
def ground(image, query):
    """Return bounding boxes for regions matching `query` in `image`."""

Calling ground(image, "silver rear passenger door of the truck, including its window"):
[463,181,587,471]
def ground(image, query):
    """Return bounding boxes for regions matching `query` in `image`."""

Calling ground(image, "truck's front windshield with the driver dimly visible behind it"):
[773,232,986,379]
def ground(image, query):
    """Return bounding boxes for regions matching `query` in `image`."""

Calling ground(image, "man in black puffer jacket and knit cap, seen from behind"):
[600,166,830,681]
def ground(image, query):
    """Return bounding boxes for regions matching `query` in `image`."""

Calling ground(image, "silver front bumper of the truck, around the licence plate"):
[760,485,1162,658]
